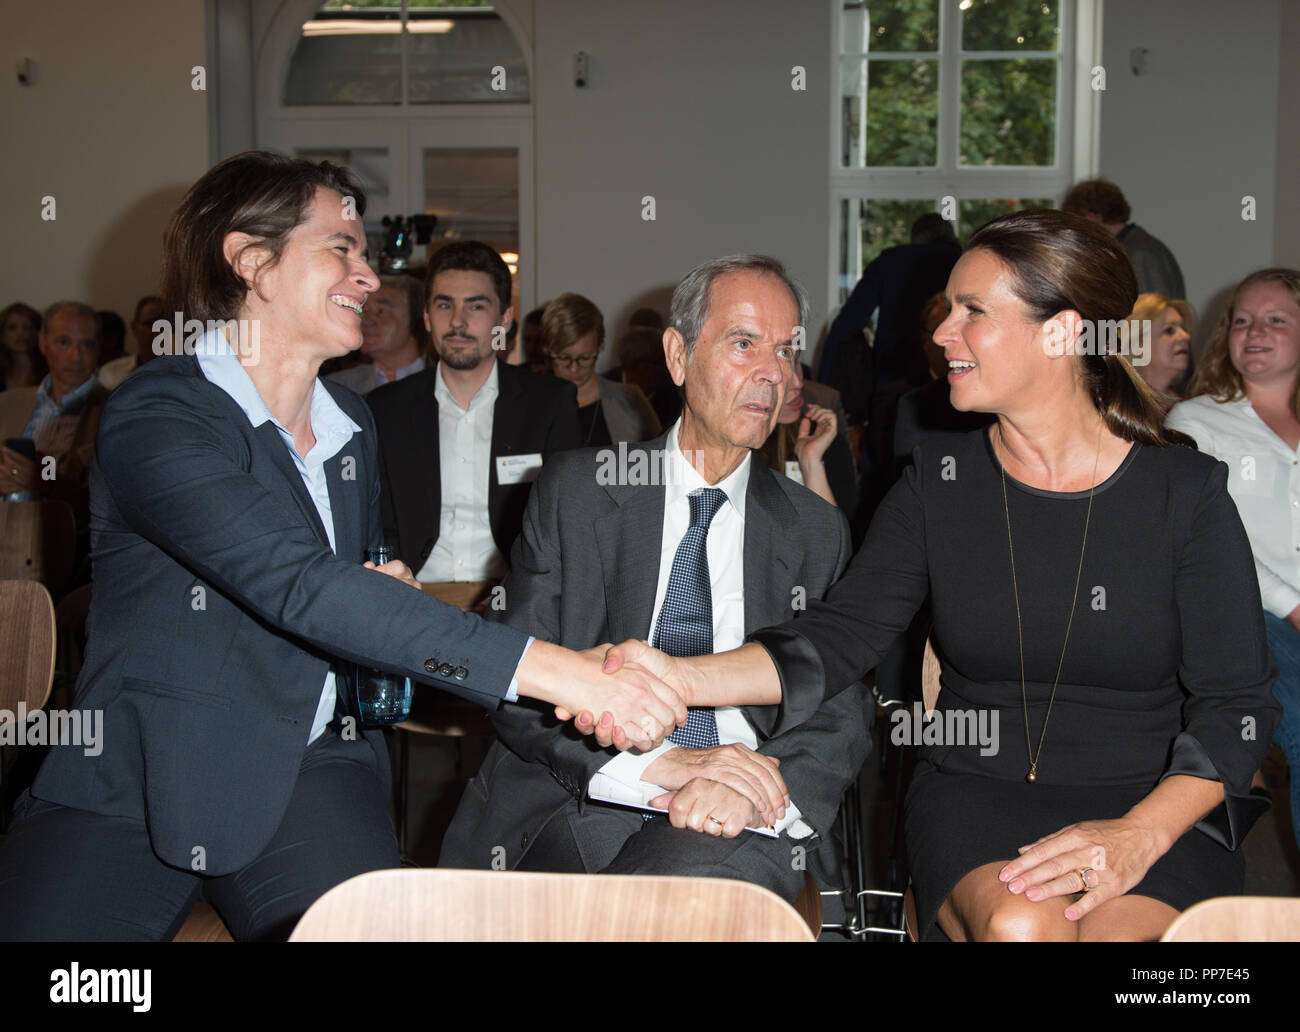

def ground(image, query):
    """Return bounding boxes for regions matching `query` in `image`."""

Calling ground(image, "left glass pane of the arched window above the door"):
[285,4,402,105]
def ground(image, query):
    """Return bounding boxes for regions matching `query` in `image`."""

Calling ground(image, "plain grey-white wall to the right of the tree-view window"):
[1100,0,1297,335]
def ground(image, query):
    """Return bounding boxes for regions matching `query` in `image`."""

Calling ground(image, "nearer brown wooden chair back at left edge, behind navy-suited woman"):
[0,579,55,714]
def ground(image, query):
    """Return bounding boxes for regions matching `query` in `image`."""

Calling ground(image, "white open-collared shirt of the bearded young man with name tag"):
[416,360,506,584]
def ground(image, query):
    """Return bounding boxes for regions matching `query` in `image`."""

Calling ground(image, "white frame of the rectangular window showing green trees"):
[827,0,1104,318]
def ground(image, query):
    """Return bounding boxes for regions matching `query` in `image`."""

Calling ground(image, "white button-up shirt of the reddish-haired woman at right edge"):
[1165,395,1300,619]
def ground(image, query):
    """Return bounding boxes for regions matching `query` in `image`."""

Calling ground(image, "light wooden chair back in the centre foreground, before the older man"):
[289,870,813,942]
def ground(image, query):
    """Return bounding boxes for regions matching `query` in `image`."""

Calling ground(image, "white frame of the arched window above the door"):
[254,0,537,305]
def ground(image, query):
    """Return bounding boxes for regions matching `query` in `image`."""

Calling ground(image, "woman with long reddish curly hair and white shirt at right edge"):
[1167,269,1300,841]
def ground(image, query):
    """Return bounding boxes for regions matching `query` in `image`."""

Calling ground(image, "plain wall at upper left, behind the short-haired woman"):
[0,0,208,340]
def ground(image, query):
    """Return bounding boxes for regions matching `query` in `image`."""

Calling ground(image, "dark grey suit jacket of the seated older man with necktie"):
[439,435,870,870]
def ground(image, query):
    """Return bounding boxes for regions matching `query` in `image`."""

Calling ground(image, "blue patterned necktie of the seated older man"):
[653,487,727,749]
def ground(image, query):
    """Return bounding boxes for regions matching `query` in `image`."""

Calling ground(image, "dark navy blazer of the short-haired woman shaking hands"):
[33,356,525,875]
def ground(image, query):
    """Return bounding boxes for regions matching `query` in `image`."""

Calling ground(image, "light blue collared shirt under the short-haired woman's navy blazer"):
[195,330,361,742]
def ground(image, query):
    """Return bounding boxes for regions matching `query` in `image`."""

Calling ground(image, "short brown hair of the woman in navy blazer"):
[163,151,365,321]
